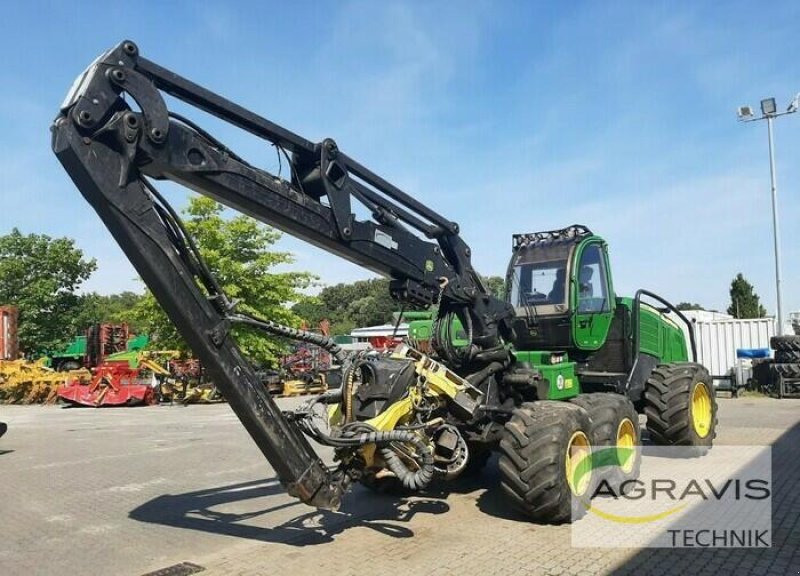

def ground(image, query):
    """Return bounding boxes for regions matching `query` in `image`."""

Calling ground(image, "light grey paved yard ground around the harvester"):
[0,398,800,576]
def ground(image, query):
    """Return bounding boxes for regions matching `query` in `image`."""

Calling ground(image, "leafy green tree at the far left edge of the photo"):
[0,228,97,356]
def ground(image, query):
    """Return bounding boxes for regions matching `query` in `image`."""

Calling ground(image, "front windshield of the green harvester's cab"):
[511,259,567,307]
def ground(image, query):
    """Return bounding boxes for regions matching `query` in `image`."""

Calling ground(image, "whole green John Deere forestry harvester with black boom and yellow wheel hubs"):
[52,41,716,522]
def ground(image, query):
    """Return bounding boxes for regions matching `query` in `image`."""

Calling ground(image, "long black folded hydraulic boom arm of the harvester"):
[53,41,511,508]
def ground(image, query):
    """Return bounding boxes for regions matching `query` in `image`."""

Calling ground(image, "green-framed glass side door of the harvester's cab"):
[570,238,616,350]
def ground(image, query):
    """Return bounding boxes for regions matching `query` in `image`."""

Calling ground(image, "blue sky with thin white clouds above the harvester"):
[0,0,800,313]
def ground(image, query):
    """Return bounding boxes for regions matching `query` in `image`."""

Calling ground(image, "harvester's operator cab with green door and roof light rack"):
[506,225,615,350]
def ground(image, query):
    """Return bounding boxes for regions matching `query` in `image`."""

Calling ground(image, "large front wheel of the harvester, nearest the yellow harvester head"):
[499,400,593,523]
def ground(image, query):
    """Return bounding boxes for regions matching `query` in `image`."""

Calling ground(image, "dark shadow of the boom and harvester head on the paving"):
[129,478,450,546]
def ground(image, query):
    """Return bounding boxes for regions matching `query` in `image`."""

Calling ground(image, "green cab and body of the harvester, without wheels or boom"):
[408,226,693,403]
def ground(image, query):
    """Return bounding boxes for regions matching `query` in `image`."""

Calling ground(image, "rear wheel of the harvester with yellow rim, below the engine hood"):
[644,362,717,453]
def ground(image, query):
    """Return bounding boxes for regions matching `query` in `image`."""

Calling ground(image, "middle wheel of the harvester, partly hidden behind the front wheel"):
[570,392,642,487]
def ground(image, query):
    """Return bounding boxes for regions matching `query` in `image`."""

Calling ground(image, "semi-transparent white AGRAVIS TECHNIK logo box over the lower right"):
[572,446,772,548]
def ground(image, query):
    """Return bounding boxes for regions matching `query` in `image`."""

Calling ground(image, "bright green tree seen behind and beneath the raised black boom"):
[135,197,314,364]
